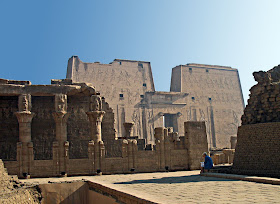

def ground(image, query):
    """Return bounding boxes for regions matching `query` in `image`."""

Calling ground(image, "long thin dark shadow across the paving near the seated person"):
[114,175,237,184]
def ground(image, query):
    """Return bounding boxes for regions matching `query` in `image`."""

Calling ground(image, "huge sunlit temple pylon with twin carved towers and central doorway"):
[66,56,244,148]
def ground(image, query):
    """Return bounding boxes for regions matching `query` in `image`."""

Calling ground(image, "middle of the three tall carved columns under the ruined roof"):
[53,94,69,176]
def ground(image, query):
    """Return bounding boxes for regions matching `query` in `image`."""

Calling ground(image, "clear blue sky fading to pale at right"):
[0,0,280,101]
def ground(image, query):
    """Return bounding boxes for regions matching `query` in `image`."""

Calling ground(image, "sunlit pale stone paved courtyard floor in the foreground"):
[21,171,280,204]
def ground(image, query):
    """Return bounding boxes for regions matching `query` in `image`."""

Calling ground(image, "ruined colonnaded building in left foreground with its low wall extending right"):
[0,79,208,178]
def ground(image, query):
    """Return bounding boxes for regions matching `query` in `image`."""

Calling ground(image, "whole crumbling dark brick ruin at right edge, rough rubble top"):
[233,65,280,177]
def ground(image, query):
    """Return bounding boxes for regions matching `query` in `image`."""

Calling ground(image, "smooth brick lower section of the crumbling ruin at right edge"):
[233,122,280,177]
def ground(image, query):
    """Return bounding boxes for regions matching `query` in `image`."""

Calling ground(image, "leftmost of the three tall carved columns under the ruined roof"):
[15,94,34,177]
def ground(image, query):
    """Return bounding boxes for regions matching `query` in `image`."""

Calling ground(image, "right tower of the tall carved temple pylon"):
[170,64,244,148]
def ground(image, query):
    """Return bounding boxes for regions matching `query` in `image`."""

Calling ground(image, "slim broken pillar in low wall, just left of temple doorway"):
[155,127,165,170]
